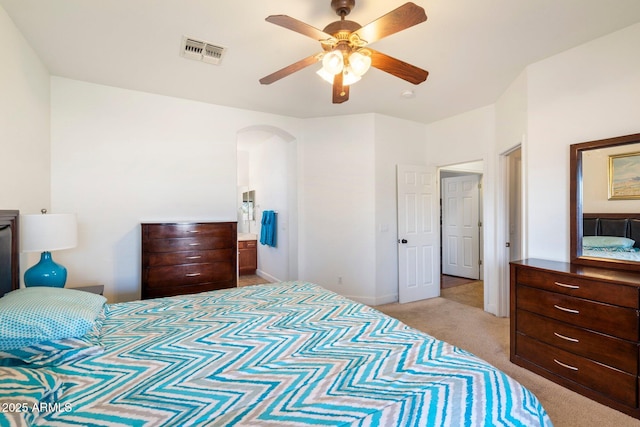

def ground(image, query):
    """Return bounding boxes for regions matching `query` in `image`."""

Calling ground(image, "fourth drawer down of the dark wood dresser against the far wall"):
[146,262,236,294]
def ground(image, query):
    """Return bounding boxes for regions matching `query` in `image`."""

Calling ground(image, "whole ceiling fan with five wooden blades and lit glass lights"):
[260,0,429,104]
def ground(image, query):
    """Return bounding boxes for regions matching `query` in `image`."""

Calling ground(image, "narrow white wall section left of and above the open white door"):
[373,114,427,305]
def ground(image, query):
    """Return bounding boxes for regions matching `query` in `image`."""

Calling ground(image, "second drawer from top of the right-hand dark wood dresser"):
[516,285,638,341]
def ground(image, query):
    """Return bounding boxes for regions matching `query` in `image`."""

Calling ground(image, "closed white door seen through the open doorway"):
[442,175,480,280]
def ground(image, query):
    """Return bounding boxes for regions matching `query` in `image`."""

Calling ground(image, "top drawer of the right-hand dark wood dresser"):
[516,269,639,309]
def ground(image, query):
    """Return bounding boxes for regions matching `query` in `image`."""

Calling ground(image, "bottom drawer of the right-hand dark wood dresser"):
[515,333,637,408]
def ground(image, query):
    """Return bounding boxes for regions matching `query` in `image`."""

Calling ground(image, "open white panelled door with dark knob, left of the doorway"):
[397,165,440,303]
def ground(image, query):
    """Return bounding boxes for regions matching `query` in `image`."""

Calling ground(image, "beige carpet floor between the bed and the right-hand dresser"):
[376,296,640,427]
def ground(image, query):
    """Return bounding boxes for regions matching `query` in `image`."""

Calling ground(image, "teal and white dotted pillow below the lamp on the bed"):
[0,286,106,351]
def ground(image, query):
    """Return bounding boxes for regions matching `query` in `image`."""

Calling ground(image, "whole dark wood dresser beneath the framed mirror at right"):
[511,259,640,418]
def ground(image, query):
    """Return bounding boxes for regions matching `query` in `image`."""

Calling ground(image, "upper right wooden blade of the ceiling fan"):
[354,2,427,43]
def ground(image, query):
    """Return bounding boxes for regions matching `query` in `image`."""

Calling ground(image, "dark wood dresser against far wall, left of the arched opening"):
[141,222,238,299]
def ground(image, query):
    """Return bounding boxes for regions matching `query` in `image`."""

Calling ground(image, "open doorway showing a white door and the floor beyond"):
[439,160,484,310]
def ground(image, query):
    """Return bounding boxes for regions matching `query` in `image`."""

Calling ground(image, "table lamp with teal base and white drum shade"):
[20,209,78,288]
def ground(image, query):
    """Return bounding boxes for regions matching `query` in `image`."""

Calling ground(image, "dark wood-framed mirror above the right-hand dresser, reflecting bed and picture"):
[570,134,640,271]
